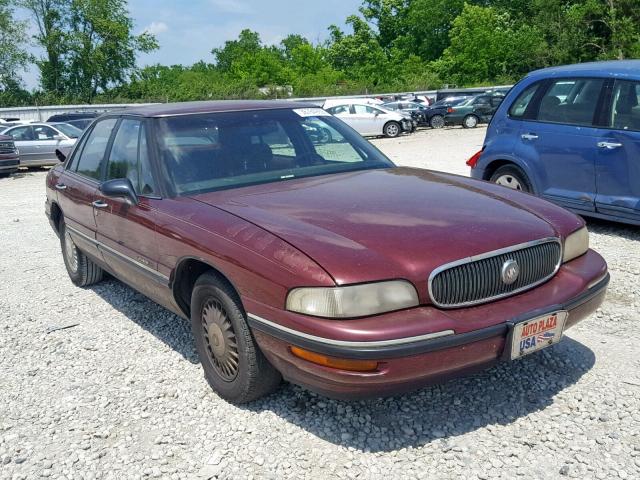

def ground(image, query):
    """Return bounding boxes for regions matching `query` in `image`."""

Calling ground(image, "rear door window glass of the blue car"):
[537,78,604,126]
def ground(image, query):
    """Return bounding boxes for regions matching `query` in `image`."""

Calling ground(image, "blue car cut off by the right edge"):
[467,60,640,225]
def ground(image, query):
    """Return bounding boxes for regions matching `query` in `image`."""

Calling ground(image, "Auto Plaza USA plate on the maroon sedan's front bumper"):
[511,310,568,360]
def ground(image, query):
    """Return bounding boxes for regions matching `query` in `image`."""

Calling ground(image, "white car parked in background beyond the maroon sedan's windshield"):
[324,100,415,137]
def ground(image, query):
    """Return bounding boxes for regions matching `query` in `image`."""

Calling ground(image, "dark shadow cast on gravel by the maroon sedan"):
[91,279,595,452]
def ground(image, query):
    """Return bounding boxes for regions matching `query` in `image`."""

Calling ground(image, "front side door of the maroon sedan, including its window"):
[93,117,168,299]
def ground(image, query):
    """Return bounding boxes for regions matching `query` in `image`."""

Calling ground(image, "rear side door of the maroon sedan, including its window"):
[55,118,116,260]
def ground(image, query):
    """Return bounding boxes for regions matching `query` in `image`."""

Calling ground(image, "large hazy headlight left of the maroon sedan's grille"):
[287,280,419,318]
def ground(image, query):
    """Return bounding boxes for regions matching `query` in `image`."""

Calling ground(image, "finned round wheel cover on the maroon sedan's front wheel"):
[202,298,239,382]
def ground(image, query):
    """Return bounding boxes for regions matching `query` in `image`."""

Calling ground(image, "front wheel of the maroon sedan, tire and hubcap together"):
[191,272,282,404]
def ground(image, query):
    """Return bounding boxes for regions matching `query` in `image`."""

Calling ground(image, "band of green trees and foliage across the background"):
[0,0,640,106]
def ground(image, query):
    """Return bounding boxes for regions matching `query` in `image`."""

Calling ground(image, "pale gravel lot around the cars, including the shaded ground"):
[0,128,640,479]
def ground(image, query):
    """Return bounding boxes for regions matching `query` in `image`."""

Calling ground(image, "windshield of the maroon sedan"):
[156,108,394,195]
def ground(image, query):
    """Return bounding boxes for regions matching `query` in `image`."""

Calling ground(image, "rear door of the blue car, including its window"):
[514,78,604,212]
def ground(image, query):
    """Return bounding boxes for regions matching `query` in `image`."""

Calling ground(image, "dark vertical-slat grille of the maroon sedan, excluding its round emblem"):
[429,238,562,308]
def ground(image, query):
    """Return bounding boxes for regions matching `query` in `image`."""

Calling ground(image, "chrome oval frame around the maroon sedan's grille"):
[428,237,564,309]
